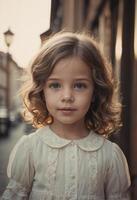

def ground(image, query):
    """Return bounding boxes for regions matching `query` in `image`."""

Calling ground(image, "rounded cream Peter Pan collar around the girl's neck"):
[37,126,105,151]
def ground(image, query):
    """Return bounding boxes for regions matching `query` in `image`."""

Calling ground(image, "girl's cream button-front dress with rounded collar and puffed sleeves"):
[1,126,130,200]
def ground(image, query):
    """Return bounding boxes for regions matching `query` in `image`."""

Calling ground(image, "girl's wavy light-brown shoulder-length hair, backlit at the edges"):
[21,32,121,135]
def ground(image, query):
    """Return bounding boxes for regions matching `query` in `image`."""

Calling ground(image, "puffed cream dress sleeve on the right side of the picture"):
[105,143,131,200]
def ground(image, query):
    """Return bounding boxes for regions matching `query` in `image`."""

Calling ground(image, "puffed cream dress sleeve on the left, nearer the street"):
[1,136,34,200]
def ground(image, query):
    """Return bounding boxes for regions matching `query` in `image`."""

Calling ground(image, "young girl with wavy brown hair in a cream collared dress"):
[2,33,130,200]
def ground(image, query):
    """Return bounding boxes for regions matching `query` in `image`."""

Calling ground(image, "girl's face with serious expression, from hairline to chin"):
[44,57,94,128]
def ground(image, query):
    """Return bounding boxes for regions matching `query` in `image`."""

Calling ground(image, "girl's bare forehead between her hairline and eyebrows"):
[51,57,91,78]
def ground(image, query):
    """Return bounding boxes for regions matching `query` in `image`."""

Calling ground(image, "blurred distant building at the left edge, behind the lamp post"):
[0,52,22,112]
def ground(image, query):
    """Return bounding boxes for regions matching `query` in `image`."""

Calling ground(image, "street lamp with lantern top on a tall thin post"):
[4,29,14,125]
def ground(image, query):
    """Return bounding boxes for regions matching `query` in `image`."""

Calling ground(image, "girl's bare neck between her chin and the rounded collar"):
[50,122,89,140]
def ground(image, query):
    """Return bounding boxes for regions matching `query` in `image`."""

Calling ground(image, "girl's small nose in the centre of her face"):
[61,88,74,103]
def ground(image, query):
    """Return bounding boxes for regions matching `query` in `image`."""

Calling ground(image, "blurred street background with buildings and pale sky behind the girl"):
[0,0,137,200]
